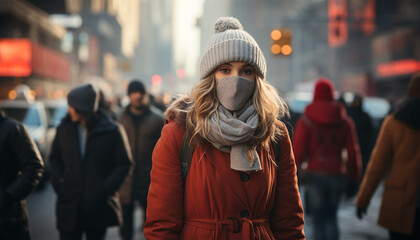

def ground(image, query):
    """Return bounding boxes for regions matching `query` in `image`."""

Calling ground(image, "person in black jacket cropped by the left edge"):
[0,111,44,240]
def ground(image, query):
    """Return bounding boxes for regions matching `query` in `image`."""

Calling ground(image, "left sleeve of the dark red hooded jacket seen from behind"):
[293,118,309,168]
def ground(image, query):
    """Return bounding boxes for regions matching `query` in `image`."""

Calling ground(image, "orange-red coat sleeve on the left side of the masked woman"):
[144,122,184,240]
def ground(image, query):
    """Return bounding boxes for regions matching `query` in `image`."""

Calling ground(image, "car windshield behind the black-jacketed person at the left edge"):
[2,107,41,127]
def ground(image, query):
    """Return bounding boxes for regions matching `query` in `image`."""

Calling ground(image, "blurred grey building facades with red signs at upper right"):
[200,0,420,98]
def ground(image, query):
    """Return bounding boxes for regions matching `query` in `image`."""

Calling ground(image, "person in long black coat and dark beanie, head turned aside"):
[50,84,132,240]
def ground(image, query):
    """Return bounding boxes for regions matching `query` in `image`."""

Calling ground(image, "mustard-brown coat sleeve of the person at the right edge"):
[356,117,393,208]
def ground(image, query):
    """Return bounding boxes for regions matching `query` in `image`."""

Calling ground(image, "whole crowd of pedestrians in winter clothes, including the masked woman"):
[0,17,420,240]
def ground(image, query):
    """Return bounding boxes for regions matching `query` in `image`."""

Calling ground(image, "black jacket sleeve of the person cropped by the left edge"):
[6,124,44,201]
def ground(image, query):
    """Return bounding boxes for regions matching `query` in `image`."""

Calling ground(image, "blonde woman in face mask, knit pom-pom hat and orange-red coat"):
[144,17,305,240]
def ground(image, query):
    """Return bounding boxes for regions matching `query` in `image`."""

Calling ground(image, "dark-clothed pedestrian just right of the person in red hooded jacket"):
[348,94,374,172]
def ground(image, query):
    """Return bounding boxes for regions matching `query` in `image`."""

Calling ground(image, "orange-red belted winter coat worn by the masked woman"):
[144,114,305,240]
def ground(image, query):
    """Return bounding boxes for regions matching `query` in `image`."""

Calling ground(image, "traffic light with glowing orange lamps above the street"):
[271,28,293,56]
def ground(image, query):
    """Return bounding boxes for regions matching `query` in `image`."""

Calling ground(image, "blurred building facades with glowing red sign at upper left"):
[0,0,140,99]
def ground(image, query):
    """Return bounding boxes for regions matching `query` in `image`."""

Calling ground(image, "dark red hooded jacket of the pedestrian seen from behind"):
[293,101,362,181]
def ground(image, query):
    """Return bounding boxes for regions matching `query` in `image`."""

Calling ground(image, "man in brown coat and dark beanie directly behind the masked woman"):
[119,80,165,240]
